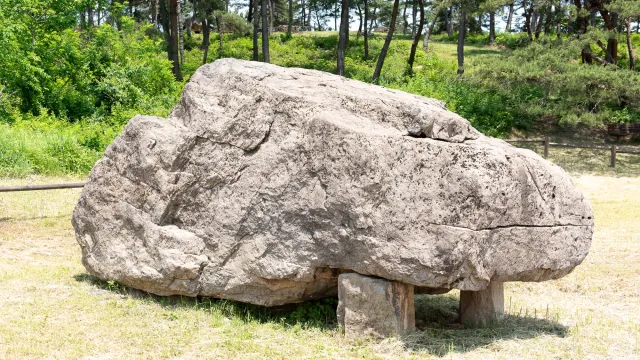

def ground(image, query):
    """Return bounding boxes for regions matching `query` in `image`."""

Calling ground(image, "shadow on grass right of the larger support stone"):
[403,295,568,356]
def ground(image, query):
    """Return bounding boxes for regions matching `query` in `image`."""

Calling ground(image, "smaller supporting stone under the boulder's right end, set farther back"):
[460,281,504,326]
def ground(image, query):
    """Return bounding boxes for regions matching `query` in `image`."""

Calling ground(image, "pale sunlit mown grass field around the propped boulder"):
[0,162,640,359]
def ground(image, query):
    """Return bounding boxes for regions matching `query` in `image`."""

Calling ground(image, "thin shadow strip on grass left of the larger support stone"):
[74,274,338,329]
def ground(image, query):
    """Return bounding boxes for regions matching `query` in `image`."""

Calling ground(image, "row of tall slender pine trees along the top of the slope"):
[63,0,640,81]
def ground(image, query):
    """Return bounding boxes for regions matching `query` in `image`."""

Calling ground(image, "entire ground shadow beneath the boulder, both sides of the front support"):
[74,273,568,356]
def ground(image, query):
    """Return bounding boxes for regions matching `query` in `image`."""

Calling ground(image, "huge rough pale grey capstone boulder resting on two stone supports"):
[73,59,593,305]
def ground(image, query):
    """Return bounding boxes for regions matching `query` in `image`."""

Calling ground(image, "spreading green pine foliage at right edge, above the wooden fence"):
[468,41,640,125]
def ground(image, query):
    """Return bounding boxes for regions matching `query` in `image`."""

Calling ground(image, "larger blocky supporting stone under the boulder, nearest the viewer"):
[338,273,416,338]
